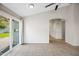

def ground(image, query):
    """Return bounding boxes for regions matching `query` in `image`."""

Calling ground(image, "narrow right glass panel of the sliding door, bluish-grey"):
[12,20,19,47]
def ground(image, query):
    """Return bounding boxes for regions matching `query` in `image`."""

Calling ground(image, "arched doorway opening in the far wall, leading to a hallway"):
[49,19,65,43]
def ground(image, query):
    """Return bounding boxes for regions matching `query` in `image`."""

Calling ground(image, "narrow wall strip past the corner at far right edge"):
[73,4,79,46]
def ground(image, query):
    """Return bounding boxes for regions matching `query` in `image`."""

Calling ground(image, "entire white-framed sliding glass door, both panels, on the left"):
[0,16,21,55]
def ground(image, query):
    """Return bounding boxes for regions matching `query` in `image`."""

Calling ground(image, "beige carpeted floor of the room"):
[8,37,79,56]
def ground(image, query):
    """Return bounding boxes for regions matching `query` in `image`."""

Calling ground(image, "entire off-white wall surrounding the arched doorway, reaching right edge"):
[24,4,79,46]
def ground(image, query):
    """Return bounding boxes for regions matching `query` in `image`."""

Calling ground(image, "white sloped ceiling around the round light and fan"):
[3,3,69,17]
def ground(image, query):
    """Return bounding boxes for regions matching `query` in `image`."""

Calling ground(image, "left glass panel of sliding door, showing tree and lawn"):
[0,16,10,55]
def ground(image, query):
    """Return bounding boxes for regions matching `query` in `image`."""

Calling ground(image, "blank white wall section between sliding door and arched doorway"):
[24,13,49,43]
